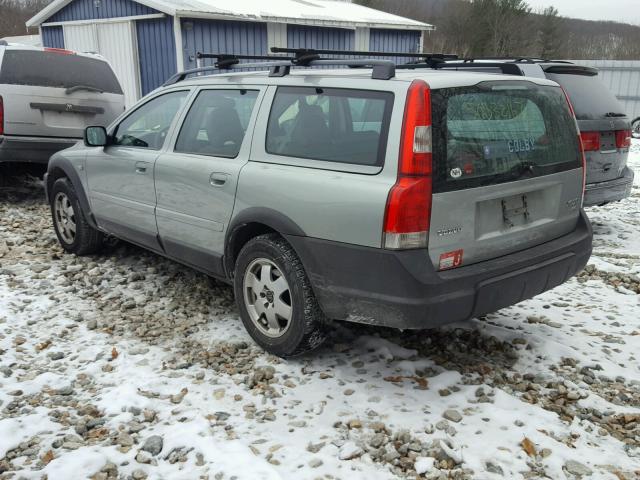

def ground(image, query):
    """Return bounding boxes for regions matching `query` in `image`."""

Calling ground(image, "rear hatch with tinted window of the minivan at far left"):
[0,49,124,138]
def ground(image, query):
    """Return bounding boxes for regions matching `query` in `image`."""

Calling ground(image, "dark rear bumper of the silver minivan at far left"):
[0,136,79,165]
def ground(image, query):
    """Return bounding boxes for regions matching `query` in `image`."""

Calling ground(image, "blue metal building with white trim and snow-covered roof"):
[27,0,433,104]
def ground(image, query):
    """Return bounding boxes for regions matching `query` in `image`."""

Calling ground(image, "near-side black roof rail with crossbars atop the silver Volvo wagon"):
[163,48,396,87]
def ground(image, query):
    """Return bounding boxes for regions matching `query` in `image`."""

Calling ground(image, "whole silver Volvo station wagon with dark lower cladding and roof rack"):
[45,50,592,357]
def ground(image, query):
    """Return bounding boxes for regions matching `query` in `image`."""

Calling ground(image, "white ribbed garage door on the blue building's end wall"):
[64,22,140,106]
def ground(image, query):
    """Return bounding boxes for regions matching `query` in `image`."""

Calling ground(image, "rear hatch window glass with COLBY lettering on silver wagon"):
[432,82,582,192]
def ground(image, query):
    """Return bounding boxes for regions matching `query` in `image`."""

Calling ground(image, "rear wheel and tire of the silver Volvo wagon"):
[234,234,327,358]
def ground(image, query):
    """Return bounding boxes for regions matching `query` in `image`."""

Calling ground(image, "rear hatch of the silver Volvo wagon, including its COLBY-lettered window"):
[429,80,583,270]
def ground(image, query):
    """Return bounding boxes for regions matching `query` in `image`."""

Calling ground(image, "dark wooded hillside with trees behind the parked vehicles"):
[354,0,640,60]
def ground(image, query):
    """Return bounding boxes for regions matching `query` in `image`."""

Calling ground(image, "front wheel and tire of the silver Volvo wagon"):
[50,178,104,256]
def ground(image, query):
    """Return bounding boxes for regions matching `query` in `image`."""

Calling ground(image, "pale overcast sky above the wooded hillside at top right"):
[527,0,640,25]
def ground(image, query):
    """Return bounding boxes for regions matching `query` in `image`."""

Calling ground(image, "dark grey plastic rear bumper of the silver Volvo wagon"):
[287,212,592,329]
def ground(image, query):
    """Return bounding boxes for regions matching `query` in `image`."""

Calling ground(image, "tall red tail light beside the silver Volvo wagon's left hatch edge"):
[383,80,433,250]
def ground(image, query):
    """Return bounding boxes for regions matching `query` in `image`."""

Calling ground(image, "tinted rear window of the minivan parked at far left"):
[0,50,122,94]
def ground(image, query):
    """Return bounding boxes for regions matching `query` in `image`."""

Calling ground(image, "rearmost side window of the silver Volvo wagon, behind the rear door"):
[266,87,393,166]
